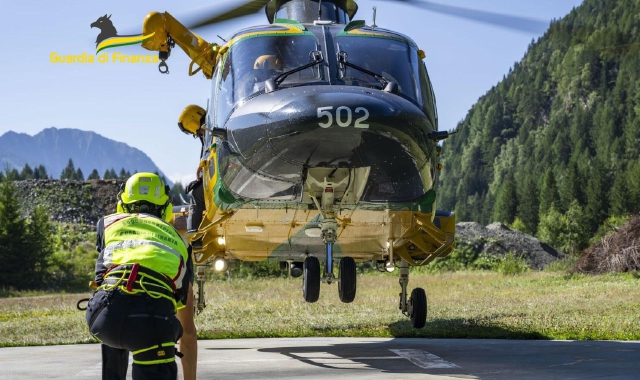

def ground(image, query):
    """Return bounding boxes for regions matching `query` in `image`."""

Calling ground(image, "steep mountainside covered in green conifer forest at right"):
[438,0,640,236]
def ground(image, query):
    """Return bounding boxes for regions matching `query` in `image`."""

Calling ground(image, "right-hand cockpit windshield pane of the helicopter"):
[336,36,422,105]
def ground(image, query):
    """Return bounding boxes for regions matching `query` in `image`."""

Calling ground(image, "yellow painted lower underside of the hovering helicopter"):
[185,209,455,265]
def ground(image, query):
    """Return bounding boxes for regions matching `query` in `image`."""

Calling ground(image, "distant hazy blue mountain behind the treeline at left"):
[0,127,169,182]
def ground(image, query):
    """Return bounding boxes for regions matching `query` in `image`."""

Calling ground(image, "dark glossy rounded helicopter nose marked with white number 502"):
[227,86,429,168]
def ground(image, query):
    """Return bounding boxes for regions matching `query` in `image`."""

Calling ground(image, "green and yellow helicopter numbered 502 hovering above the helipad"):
[135,0,540,328]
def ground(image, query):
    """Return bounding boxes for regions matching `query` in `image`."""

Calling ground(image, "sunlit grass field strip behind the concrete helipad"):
[0,271,640,347]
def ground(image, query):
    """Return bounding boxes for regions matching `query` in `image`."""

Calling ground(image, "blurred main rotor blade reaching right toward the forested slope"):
[378,0,550,34]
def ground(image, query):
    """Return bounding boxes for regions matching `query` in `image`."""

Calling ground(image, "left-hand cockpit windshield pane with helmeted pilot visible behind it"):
[218,35,320,119]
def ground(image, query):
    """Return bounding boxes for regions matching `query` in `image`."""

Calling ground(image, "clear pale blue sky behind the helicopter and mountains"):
[0,0,582,183]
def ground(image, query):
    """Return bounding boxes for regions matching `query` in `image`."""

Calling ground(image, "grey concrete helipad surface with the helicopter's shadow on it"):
[0,338,640,380]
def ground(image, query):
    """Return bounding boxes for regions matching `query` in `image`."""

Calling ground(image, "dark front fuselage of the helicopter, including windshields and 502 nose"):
[207,19,438,212]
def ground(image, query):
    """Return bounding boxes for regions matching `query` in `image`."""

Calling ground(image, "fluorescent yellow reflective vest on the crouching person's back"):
[102,213,188,289]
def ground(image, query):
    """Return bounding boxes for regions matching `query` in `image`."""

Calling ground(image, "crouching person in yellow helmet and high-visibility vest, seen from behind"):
[86,173,197,380]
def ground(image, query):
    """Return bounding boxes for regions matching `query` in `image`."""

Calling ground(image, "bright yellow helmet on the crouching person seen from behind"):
[116,173,173,222]
